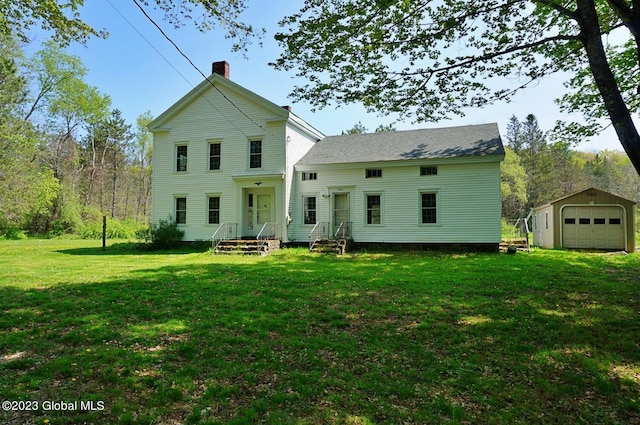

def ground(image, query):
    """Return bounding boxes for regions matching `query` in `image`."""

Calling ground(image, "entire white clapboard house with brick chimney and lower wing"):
[149,62,504,249]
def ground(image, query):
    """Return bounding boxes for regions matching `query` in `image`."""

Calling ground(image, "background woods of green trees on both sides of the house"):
[0,41,640,239]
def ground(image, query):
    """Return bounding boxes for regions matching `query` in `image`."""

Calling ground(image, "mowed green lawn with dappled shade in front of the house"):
[0,240,640,424]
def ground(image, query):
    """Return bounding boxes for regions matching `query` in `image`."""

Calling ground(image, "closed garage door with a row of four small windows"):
[561,205,625,249]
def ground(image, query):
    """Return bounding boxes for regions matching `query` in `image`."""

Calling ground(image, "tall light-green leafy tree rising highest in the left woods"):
[24,41,111,231]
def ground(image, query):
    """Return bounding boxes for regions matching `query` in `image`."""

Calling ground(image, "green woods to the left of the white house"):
[0,37,152,237]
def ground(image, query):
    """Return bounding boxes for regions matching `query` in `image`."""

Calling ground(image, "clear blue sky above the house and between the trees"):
[27,0,622,151]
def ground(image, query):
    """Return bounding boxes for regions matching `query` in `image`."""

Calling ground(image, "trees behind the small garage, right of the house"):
[501,115,640,219]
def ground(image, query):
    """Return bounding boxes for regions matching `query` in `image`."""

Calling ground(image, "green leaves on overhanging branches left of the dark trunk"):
[272,0,580,121]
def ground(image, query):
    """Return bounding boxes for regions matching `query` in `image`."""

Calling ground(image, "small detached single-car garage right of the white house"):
[532,188,636,252]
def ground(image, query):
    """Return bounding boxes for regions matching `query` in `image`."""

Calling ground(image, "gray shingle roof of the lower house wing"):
[298,123,504,165]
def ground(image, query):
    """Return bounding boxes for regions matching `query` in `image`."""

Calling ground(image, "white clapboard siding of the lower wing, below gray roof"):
[289,159,501,243]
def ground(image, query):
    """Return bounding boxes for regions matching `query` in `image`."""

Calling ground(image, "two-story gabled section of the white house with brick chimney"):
[148,62,324,242]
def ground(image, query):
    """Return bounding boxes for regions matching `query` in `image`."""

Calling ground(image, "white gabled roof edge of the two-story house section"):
[147,73,324,138]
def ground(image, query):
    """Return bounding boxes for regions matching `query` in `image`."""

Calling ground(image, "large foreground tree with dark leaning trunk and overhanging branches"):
[272,0,640,172]
